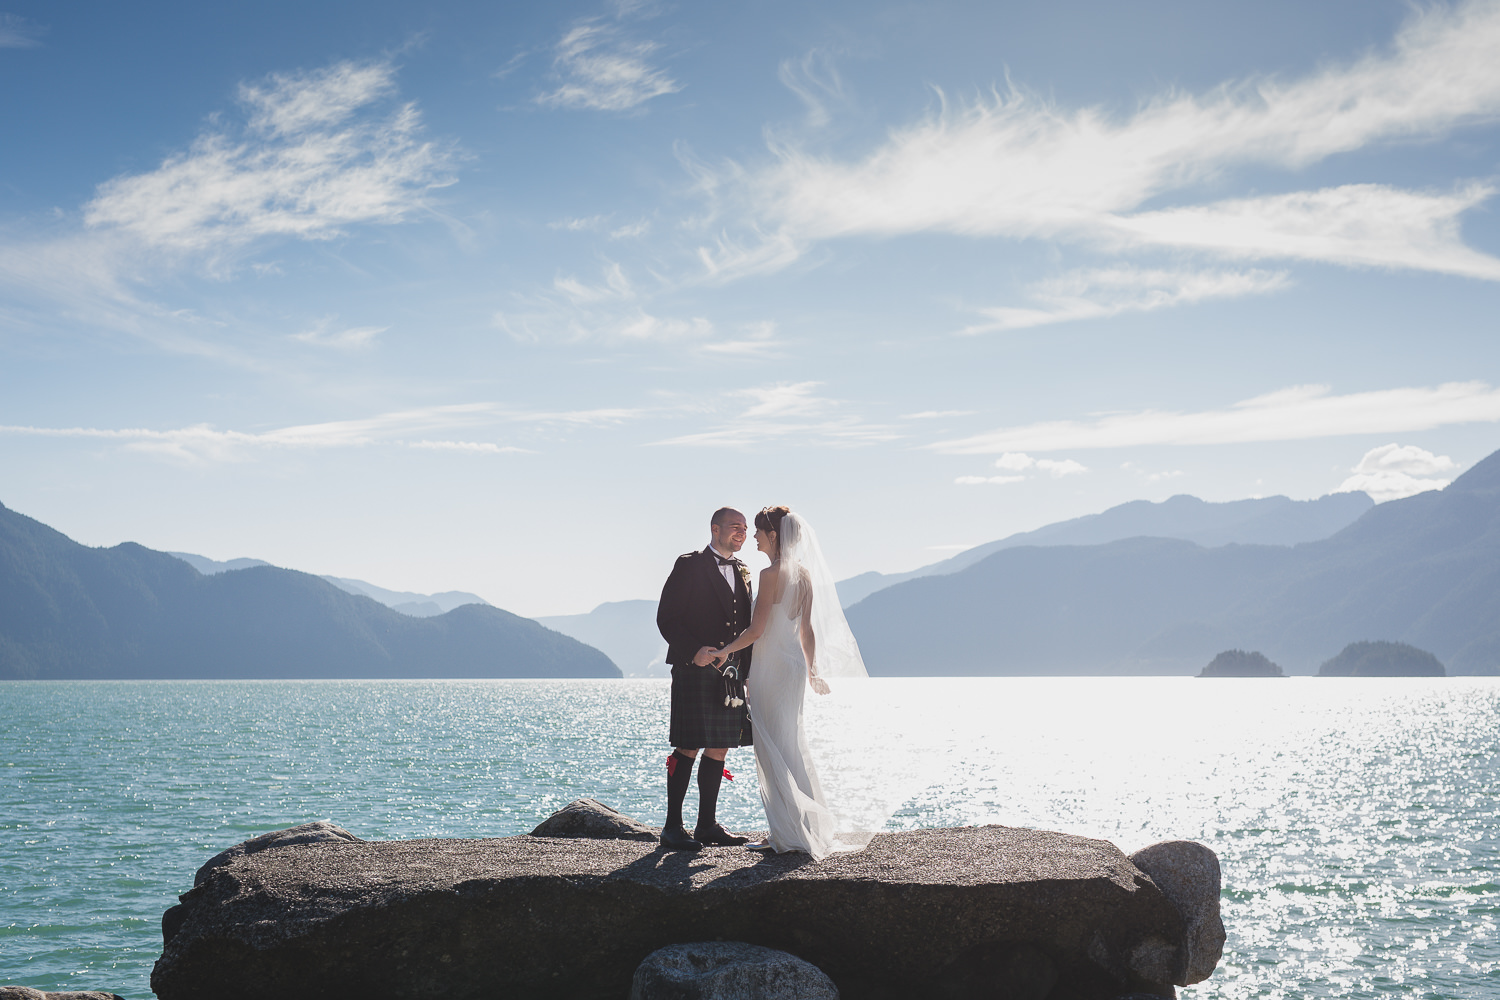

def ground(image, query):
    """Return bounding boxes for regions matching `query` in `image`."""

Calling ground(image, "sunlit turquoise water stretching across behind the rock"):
[0,678,1500,1000]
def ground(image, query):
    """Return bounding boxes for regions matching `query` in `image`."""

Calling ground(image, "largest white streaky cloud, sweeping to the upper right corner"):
[732,0,1500,279]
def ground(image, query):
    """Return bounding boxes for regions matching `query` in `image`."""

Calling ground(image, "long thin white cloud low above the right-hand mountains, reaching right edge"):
[929,382,1500,454]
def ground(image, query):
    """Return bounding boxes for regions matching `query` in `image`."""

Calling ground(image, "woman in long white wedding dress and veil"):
[716,507,870,859]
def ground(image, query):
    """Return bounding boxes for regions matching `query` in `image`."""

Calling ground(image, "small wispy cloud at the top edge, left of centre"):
[537,18,683,111]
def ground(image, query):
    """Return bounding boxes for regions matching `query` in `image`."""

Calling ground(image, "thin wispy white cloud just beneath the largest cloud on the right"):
[963,267,1289,333]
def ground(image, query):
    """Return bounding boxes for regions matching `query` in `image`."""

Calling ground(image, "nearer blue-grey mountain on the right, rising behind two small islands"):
[848,453,1500,675]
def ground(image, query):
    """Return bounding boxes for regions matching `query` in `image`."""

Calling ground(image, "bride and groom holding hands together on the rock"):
[657,507,869,859]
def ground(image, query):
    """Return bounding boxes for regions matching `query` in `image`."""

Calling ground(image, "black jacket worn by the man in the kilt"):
[657,549,750,679]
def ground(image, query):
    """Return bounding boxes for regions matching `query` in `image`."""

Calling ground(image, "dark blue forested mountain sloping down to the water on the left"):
[0,505,620,679]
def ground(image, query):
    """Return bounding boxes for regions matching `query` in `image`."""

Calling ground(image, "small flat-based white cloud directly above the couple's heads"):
[656,382,900,447]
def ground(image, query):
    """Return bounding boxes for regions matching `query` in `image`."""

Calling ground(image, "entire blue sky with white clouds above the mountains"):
[0,0,1500,615]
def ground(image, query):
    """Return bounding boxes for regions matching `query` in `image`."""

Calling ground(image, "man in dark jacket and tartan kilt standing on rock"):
[657,507,753,850]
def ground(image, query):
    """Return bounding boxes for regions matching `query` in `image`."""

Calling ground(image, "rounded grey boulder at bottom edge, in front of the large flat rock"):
[630,942,839,1000]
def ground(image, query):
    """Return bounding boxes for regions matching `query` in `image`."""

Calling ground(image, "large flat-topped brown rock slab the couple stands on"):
[152,826,1206,1000]
